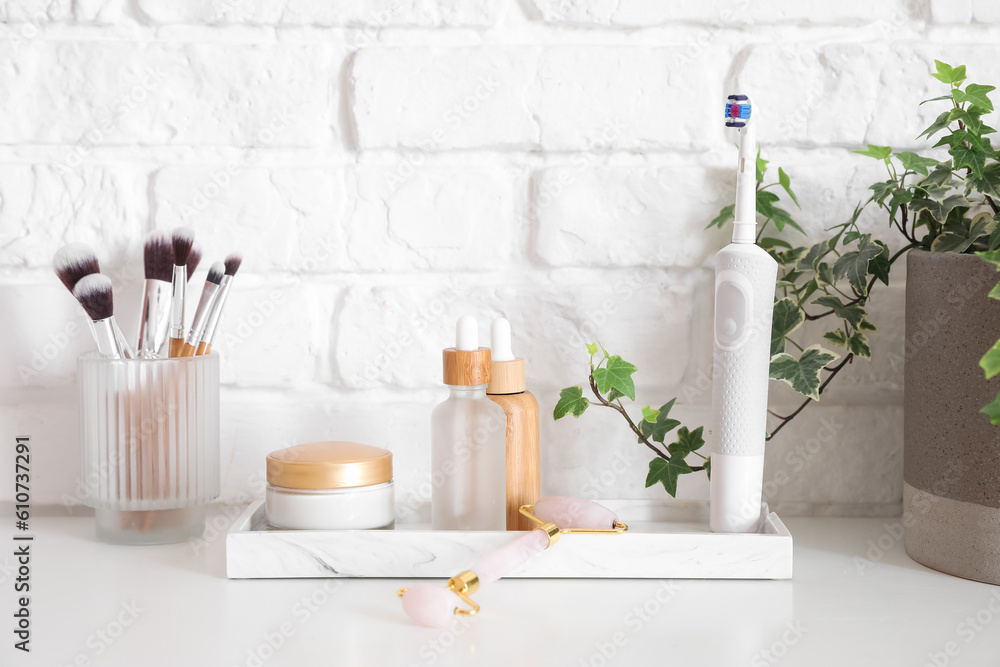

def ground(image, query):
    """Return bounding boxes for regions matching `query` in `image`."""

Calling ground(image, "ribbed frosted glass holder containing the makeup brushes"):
[78,353,220,544]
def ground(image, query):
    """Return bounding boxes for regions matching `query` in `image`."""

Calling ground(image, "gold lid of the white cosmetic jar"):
[267,442,392,489]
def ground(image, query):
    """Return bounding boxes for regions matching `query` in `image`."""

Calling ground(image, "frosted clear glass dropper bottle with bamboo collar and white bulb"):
[431,315,507,530]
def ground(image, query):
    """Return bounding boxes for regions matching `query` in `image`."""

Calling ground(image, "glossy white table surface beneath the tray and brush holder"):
[7,513,1000,667]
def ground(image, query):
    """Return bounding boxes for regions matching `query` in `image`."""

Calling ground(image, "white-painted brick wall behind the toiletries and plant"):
[0,0,988,514]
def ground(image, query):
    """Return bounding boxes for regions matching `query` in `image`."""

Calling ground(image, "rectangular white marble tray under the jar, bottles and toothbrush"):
[226,500,792,579]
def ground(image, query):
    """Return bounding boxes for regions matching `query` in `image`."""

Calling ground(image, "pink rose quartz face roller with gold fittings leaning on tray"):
[396,496,628,628]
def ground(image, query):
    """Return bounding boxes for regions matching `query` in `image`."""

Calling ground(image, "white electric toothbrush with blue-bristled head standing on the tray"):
[710,95,778,533]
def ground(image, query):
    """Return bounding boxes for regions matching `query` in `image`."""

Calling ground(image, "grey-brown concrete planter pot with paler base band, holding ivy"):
[903,250,1000,584]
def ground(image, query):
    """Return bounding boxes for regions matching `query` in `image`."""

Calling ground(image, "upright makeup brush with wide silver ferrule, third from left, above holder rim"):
[136,231,174,358]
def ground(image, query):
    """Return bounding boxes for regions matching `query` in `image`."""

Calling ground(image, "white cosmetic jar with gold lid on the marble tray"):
[265,442,395,530]
